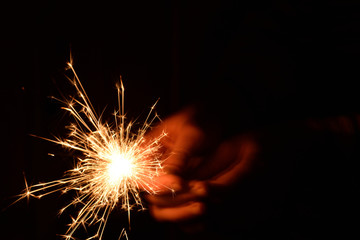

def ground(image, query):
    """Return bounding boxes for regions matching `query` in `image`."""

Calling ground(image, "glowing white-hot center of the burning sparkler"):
[107,153,133,183]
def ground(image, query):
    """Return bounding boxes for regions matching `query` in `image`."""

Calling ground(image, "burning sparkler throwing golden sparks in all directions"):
[18,60,166,240]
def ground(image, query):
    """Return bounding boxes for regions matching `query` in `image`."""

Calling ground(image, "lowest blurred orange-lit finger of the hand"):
[149,202,205,222]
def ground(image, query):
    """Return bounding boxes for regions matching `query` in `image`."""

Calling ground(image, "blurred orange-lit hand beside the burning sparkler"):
[146,109,258,222]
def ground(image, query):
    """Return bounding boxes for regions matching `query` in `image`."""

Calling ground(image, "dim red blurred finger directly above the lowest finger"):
[146,181,208,207]
